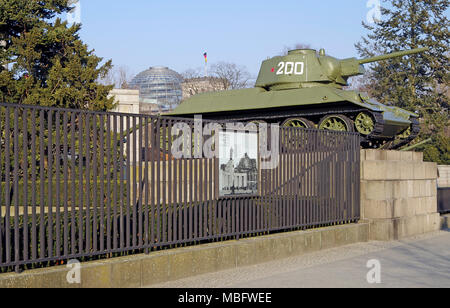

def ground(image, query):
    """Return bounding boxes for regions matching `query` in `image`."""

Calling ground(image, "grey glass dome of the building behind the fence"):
[130,66,183,109]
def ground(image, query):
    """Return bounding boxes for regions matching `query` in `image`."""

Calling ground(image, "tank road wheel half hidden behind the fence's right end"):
[319,114,355,150]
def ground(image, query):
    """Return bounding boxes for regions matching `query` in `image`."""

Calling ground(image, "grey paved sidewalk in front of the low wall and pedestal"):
[152,231,450,288]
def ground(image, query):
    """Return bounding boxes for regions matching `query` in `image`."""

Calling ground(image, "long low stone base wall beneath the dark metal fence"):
[0,220,372,288]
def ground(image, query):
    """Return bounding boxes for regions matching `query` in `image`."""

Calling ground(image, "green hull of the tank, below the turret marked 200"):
[169,86,418,148]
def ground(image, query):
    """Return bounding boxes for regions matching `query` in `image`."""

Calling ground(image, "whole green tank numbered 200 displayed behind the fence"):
[169,48,428,149]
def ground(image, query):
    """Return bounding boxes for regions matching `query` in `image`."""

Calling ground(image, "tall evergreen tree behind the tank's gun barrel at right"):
[356,0,450,164]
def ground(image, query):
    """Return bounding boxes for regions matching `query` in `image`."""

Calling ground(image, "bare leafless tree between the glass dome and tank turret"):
[211,62,251,90]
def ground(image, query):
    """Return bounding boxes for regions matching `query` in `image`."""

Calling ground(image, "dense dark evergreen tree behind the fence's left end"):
[0,0,114,111]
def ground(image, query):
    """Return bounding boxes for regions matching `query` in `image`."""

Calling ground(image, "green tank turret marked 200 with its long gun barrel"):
[256,48,428,90]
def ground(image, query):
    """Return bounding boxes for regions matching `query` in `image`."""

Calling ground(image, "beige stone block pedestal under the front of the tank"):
[361,150,440,241]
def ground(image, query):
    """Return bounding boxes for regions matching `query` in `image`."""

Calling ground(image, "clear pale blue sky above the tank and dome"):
[71,0,380,77]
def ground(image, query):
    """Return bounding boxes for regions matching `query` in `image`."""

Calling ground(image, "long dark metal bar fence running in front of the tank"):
[0,104,360,268]
